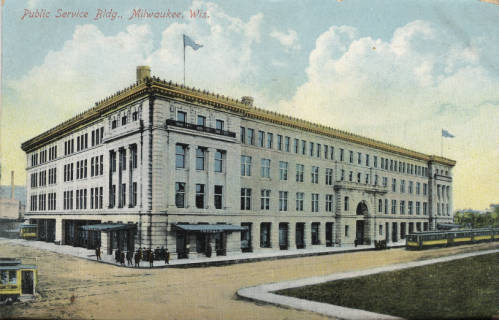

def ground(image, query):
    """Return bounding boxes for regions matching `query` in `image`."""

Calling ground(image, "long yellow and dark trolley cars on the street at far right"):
[406,228,499,250]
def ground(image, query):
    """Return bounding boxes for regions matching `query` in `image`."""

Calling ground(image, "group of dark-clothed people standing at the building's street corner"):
[95,246,170,268]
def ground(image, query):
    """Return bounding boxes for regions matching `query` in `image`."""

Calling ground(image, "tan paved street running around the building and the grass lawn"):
[0,240,499,319]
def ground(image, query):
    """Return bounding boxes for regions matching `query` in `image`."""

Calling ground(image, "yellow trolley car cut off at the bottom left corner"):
[0,258,38,302]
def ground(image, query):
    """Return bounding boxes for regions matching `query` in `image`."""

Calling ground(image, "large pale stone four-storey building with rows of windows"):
[22,67,455,258]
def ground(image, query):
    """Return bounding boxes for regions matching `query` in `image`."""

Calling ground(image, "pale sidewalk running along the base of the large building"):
[0,238,405,268]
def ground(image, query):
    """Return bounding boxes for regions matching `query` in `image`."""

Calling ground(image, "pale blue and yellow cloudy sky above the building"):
[0,0,499,210]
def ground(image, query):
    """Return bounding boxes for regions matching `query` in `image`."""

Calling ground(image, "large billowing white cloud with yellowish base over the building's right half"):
[279,21,499,208]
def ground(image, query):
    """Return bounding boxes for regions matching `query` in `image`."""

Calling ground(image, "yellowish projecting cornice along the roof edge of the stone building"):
[21,77,456,166]
